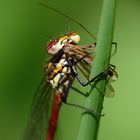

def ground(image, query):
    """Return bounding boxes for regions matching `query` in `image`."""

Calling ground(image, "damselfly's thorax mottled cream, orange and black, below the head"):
[45,54,71,93]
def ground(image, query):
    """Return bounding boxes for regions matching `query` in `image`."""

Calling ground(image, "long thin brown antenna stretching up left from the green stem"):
[38,2,97,40]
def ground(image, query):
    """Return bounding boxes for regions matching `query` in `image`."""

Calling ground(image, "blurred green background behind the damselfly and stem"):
[0,0,140,140]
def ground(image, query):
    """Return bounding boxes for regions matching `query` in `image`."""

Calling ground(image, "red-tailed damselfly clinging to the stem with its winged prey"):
[24,1,117,140]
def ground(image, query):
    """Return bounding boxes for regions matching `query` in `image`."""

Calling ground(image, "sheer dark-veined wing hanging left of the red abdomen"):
[23,77,53,140]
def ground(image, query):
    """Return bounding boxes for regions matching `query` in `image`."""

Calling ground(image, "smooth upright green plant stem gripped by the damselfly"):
[77,0,116,140]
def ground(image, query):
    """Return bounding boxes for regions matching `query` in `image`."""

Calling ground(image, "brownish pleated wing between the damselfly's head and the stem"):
[64,44,95,82]
